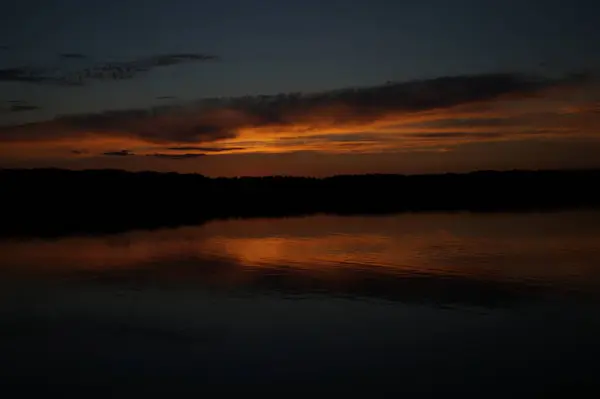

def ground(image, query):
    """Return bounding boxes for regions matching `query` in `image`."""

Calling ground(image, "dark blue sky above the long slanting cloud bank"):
[0,0,600,175]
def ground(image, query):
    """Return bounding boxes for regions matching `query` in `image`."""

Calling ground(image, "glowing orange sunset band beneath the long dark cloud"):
[0,76,600,173]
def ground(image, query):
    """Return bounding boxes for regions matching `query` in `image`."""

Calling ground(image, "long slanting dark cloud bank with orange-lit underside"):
[0,72,598,159]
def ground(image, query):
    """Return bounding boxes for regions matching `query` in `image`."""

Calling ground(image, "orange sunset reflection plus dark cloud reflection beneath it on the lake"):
[0,211,600,306]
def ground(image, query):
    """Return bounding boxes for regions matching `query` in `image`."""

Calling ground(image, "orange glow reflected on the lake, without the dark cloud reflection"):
[0,212,600,292]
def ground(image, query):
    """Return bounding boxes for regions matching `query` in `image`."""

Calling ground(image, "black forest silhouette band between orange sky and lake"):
[0,169,600,237]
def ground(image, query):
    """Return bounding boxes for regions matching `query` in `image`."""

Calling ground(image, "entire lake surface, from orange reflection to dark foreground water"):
[0,211,600,397]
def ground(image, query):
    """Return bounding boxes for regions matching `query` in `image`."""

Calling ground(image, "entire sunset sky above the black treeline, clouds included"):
[0,0,600,176]
